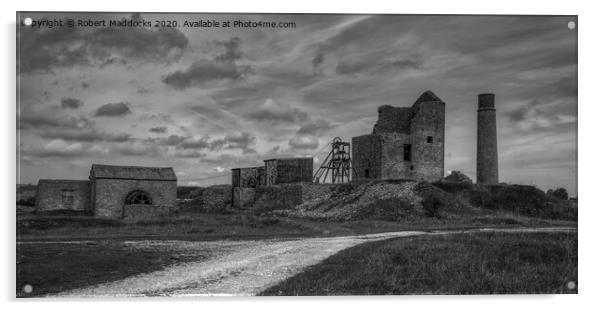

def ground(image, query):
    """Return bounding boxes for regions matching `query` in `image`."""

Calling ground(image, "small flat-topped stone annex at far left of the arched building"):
[36,180,90,212]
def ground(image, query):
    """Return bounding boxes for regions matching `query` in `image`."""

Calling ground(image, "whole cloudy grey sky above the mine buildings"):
[17,13,577,195]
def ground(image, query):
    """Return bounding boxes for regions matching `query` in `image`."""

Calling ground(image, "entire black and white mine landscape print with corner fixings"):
[15,10,576,301]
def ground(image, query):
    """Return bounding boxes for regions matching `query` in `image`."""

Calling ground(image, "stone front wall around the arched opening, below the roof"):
[92,179,177,218]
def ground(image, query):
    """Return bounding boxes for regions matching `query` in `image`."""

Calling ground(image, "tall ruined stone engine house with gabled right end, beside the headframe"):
[351,91,445,181]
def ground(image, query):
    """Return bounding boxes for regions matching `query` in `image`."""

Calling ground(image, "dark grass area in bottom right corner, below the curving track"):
[262,233,577,295]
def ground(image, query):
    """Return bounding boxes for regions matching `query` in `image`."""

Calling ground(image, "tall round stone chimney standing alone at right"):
[477,94,499,184]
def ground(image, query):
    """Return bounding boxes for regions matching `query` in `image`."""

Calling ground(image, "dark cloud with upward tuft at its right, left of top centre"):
[162,38,254,89]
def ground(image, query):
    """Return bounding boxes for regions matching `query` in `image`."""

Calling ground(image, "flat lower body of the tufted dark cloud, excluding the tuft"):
[163,59,252,89]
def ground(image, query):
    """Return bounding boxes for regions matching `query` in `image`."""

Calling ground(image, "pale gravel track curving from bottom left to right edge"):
[43,228,576,297]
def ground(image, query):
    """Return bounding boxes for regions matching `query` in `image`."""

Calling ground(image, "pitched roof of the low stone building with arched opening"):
[90,164,177,181]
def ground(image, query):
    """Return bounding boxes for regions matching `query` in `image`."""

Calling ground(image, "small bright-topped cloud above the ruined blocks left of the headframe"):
[246,98,309,123]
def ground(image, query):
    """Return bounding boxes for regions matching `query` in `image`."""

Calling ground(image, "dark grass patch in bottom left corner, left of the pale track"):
[16,242,208,297]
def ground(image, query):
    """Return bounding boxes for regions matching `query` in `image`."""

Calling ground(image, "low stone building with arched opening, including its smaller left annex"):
[36,165,177,218]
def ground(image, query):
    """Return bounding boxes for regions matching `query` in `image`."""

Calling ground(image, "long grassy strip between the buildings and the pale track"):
[17,211,577,241]
